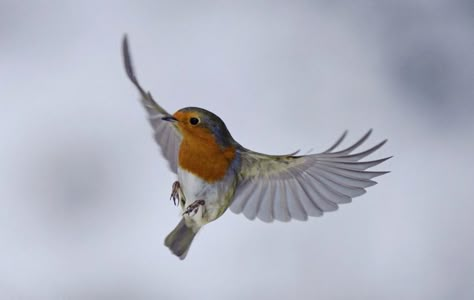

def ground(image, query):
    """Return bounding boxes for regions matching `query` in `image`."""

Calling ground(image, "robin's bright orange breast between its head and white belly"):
[178,137,235,183]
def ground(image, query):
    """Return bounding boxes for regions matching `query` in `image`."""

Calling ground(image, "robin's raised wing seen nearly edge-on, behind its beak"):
[122,36,182,173]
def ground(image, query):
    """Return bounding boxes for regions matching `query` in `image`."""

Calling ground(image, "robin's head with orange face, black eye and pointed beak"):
[162,107,235,147]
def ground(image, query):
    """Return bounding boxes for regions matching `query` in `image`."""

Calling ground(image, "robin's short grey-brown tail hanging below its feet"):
[165,218,199,259]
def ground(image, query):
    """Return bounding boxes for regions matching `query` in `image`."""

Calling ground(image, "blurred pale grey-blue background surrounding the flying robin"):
[0,0,474,299]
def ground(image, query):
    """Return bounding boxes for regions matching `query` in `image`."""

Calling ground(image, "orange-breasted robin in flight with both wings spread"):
[122,36,390,259]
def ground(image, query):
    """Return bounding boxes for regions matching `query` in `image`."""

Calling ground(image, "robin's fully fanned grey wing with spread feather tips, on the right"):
[230,130,390,222]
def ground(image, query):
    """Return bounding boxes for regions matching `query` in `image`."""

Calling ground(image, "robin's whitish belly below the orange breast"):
[178,168,234,225]
